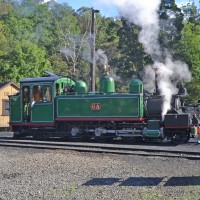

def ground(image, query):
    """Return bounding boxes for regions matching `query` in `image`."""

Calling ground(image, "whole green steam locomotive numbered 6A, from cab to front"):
[10,73,194,142]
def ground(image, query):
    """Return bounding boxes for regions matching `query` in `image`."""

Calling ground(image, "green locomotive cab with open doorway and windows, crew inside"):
[10,72,75,137]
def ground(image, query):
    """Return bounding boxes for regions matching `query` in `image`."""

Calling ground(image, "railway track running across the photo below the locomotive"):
[0,138,200,159]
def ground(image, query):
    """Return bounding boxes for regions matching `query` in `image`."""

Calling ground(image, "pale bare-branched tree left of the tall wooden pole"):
[50,4,88,78]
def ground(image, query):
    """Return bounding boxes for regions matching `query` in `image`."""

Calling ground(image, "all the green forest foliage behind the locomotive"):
[0,0,200,102]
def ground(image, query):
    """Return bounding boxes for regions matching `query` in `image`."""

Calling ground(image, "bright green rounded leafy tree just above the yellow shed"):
[1,40,51,82]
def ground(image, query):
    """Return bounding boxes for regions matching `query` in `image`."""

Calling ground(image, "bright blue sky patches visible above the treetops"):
[57,0,198,17]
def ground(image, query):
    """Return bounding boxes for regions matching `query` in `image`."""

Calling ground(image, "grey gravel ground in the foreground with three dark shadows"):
[0,147,200,200]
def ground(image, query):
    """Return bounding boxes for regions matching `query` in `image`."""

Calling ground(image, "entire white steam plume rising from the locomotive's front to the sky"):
[98,0,191,115]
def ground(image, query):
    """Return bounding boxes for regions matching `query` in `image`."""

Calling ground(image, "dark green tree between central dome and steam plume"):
[117,19,152,90]
